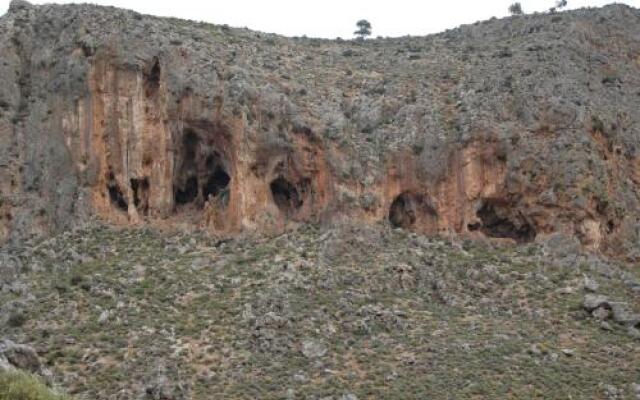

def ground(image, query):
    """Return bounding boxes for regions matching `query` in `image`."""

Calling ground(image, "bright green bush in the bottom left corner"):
[0,371,70,400]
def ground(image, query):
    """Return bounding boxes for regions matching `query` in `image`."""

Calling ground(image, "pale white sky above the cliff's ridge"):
[0,0,640,38]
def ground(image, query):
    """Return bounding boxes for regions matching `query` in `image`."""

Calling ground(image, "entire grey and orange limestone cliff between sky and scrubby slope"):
[0,1,640,260]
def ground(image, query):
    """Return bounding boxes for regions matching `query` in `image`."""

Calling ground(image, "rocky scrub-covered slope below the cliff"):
[0,225,640,400]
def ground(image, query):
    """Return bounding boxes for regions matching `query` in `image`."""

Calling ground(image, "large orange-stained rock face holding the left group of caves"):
[68,56,330,232]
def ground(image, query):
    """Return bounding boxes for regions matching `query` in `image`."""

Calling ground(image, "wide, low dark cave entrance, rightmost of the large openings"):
[468,200,537,243]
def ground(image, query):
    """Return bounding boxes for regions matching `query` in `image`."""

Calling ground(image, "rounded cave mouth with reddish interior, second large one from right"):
[389,192,438,230]
